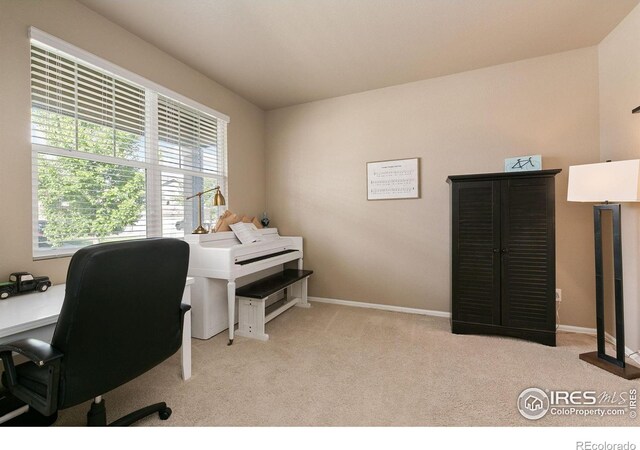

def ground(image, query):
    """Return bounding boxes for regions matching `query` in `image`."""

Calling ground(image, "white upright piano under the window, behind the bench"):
[185,228,307,345]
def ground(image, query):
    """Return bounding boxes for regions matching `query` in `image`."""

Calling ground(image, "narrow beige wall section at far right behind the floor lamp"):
[598,3,640,350]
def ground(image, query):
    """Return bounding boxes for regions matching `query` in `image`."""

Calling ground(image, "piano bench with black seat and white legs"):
[236,269,313,341]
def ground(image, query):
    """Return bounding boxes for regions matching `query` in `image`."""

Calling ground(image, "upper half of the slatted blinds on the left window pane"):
[31,45,145,160]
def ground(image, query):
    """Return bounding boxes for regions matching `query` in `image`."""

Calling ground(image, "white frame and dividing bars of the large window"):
[29,27,231,260]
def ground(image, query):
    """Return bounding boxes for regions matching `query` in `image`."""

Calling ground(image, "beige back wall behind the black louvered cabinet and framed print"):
[267,47,600,327]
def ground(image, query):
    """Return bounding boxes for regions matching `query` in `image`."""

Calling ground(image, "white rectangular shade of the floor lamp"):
[567,159,640,203]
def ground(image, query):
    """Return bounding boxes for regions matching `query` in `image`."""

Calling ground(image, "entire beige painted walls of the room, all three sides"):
[0,0,640,340]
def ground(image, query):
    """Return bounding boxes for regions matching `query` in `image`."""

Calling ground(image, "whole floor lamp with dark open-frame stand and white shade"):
[567,159,640,380]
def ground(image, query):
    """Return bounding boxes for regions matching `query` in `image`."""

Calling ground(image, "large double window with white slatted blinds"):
[31,28,229,258]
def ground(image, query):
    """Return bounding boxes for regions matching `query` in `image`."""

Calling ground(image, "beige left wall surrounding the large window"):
[0,0,265,283]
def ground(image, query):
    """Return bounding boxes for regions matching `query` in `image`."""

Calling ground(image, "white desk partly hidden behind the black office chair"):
[0,277,194,380]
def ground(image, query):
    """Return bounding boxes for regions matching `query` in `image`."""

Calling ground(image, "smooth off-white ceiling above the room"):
[79,0,640,110]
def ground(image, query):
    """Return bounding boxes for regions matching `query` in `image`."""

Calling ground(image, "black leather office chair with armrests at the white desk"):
[0,238,190,426]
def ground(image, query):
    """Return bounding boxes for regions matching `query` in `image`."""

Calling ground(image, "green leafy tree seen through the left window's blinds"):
[32,108,145,247]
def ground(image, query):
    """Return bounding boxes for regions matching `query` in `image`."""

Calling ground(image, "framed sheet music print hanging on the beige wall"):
[367,158,420,200]
